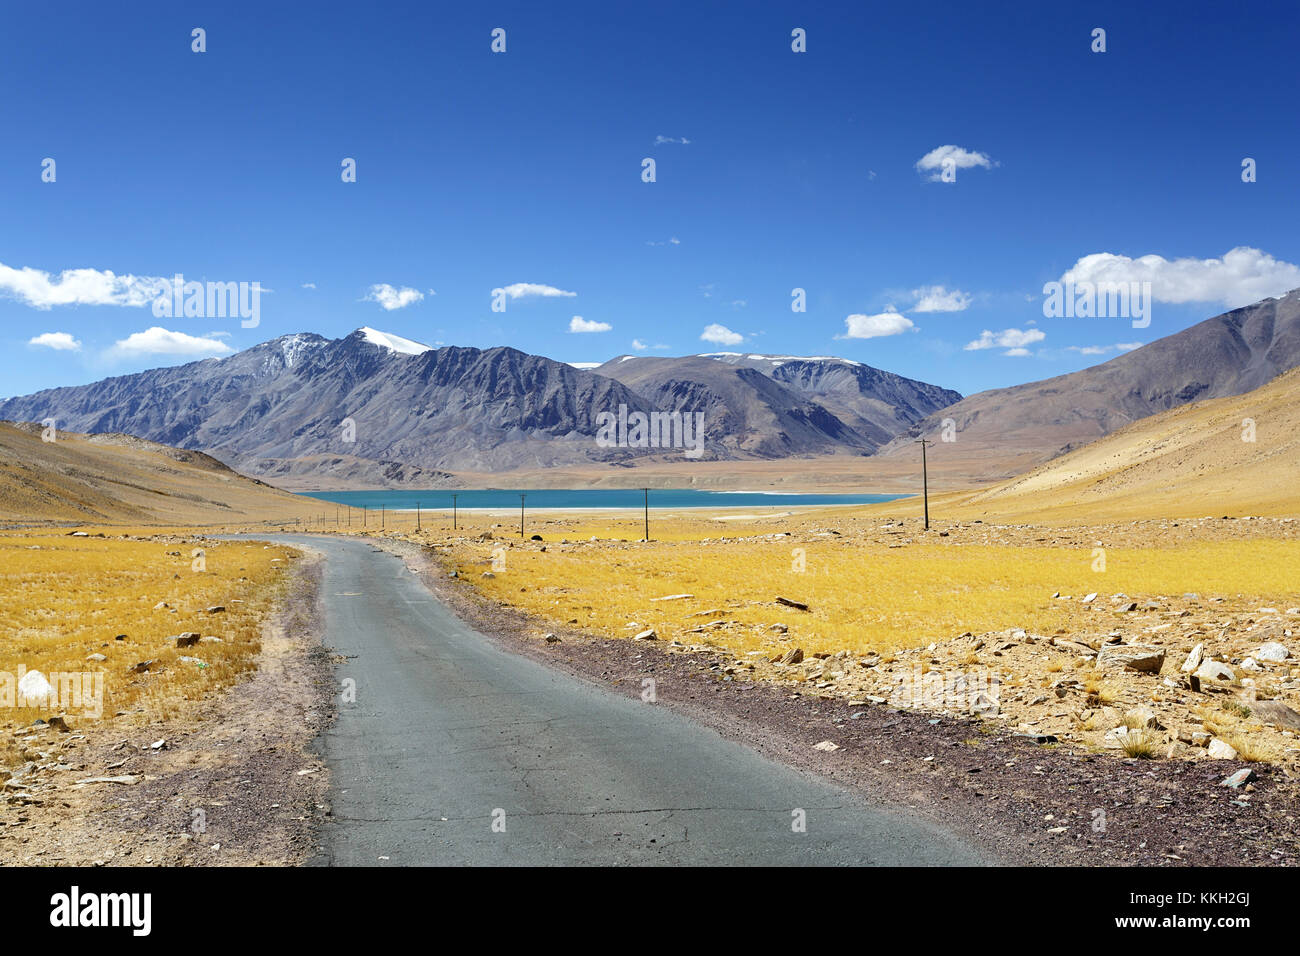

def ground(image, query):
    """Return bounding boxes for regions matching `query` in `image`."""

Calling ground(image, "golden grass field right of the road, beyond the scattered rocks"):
[451,528,1300,654]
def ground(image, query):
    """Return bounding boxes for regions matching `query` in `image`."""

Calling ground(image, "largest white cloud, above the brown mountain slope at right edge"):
[1061,246,1300,308]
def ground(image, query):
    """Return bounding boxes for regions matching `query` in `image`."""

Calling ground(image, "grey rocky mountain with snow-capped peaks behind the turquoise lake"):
[0,328,959,486]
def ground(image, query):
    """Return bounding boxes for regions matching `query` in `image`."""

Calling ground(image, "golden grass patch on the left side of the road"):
[0,533,295,763]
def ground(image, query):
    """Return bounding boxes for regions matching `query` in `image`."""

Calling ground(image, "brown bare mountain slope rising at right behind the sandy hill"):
[880,290,1300,470]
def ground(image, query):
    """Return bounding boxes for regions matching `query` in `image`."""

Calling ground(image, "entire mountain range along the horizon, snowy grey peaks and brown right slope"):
[0,290,1300,488]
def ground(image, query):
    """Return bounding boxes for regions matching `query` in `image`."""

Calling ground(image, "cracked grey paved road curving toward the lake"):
[239,536,987,865]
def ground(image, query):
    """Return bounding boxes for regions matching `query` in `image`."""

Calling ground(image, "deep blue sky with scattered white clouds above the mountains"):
[0,1,1300,395]
